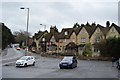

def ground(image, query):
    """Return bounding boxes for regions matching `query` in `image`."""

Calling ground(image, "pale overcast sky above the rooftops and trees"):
[0,0,119,35]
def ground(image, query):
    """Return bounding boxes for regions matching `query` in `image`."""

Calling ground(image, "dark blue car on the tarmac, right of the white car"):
[59,56,77,69]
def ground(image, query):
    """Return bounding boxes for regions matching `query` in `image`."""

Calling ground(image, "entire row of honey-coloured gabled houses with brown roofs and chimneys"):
[34,22,120,56]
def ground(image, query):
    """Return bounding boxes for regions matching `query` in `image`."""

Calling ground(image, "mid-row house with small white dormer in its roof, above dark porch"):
[59,28,77,53]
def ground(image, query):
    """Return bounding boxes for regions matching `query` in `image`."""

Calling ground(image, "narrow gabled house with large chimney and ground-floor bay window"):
[45,26,59,53]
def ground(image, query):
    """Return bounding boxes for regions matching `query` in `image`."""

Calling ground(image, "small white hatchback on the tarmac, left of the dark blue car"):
[16,56,35,67]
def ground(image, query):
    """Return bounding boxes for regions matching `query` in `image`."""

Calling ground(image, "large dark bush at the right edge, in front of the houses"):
[98,37,120,57]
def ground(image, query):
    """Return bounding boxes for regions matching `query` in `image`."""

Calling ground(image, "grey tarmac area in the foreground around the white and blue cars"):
[2,48,119,78]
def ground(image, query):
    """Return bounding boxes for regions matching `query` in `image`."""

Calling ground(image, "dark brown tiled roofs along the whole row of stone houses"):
[34,23,120,42]
